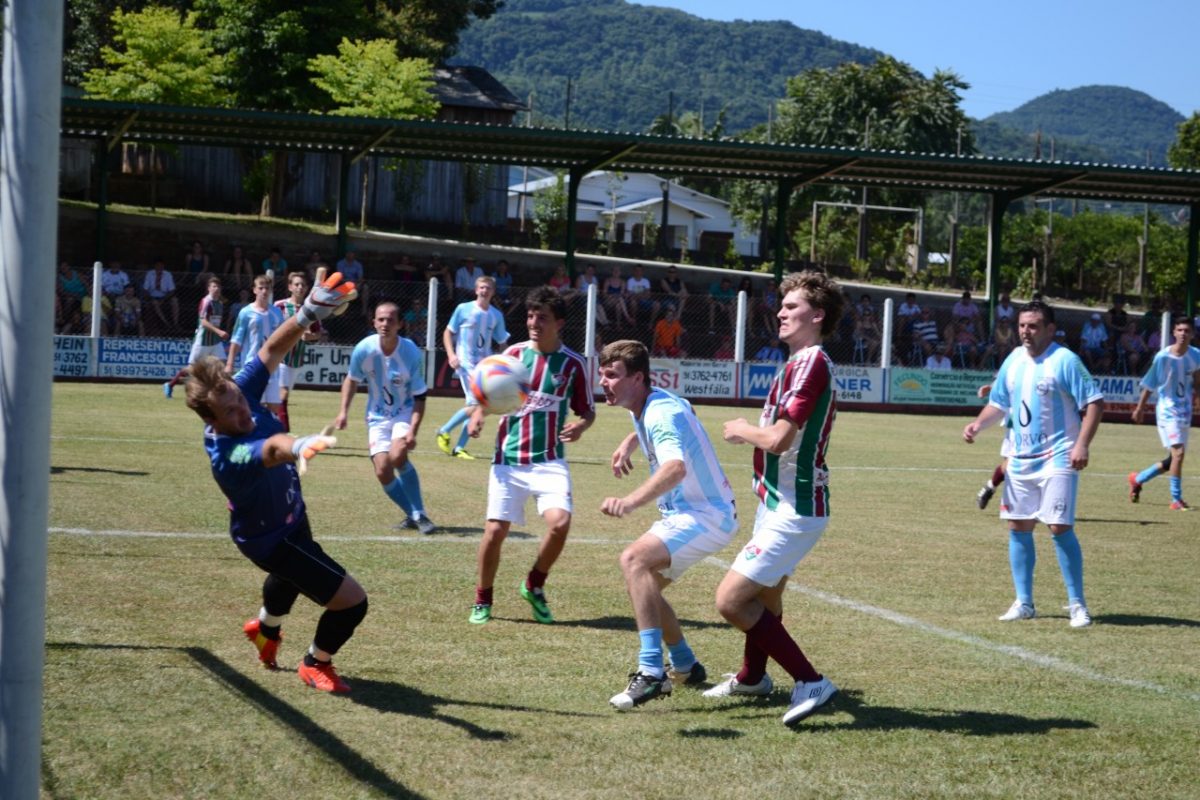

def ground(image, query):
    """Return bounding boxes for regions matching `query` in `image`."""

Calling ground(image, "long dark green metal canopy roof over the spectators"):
[61,97,1200,308]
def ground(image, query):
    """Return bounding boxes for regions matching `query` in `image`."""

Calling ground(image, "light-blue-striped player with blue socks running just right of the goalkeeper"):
[334,301,437,535]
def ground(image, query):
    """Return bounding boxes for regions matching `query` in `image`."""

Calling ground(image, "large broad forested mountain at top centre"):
[454,0,882,133]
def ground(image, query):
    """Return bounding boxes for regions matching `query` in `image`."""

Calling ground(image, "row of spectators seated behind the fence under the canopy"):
[55,241,1180,374]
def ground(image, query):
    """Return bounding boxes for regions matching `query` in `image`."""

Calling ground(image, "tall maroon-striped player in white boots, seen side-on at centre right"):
[704,271,842,724]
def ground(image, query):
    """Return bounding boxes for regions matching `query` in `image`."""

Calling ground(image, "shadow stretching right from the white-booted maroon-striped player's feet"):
[720,690,1096,736]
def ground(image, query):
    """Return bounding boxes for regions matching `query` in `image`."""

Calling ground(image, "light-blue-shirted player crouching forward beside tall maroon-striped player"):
[600,339,738,711]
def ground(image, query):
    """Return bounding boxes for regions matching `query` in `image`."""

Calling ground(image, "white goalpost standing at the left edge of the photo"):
[0,0,65,800]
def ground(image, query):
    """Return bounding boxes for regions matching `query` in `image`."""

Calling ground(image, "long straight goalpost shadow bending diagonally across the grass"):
[43,642,432,800]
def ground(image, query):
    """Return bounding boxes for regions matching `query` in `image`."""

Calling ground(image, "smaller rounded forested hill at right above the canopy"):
[980,86,1183,167]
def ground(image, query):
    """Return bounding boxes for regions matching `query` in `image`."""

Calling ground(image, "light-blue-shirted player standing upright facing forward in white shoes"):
[962,300,1104,627]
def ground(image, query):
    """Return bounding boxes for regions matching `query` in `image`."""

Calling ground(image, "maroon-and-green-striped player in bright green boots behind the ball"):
[469,287,596,625]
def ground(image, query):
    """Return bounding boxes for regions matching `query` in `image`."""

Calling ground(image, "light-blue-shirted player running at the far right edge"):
[1129,317,1200,511]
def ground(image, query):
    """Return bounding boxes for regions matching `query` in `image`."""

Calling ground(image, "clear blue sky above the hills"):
[631,0,1200,119]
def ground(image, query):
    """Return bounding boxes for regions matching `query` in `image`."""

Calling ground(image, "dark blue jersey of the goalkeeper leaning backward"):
[204,354,305,559]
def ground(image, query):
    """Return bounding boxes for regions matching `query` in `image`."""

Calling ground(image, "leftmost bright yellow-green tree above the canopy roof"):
[83,6,230,106]
